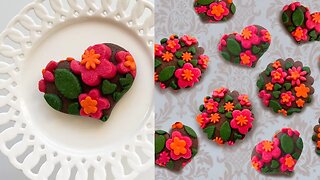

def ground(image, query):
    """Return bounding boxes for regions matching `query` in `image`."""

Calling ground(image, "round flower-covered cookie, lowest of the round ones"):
[196,87,254,145]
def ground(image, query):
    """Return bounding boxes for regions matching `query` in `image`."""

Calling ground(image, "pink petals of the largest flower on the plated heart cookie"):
[70,44,117,86]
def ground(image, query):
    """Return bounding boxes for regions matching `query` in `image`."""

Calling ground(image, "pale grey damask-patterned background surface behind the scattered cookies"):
[155,0,320,180]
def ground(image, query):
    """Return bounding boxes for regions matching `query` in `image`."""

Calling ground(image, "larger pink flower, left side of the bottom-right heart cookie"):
[256,138,281,163]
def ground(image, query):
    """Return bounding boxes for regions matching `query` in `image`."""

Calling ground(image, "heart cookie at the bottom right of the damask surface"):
[251,128,303,175]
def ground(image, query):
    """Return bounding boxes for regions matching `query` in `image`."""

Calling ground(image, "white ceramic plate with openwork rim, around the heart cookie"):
[0,0,154,180]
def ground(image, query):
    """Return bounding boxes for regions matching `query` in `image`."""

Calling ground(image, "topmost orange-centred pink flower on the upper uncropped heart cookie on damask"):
[236,26,260,49]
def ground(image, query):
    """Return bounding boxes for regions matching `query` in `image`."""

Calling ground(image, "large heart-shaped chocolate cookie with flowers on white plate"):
[39,43,136,121]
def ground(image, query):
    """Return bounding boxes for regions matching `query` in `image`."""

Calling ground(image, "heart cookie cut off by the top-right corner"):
[282,2,320,43]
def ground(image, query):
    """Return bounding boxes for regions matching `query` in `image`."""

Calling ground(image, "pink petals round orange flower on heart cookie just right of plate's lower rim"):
[166,131,192,160]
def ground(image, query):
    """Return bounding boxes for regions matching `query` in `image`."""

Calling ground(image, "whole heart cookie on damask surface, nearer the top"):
[218,25,271,68]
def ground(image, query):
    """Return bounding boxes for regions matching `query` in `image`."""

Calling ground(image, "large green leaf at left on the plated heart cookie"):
[54,69,82,99]
